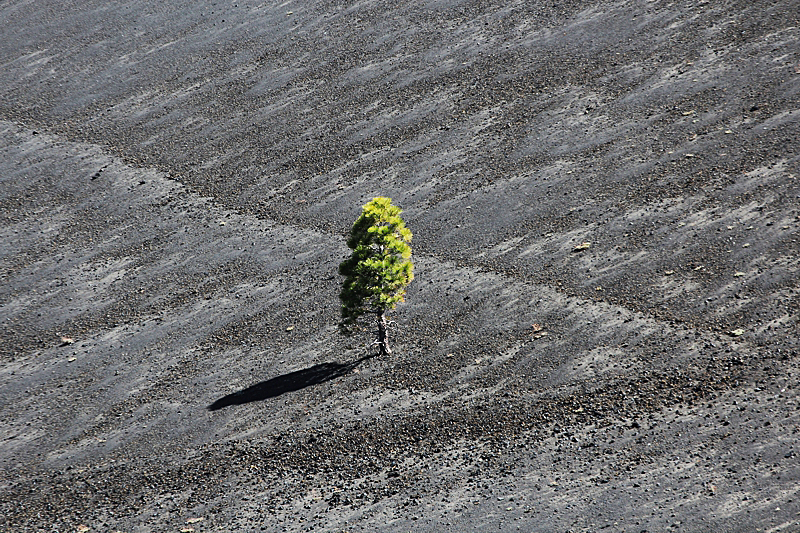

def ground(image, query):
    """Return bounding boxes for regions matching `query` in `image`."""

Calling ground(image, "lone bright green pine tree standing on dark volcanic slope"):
[339,196,414,355]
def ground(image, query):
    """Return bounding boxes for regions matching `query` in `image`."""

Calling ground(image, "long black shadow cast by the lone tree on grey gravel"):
[208,356,372,411]
